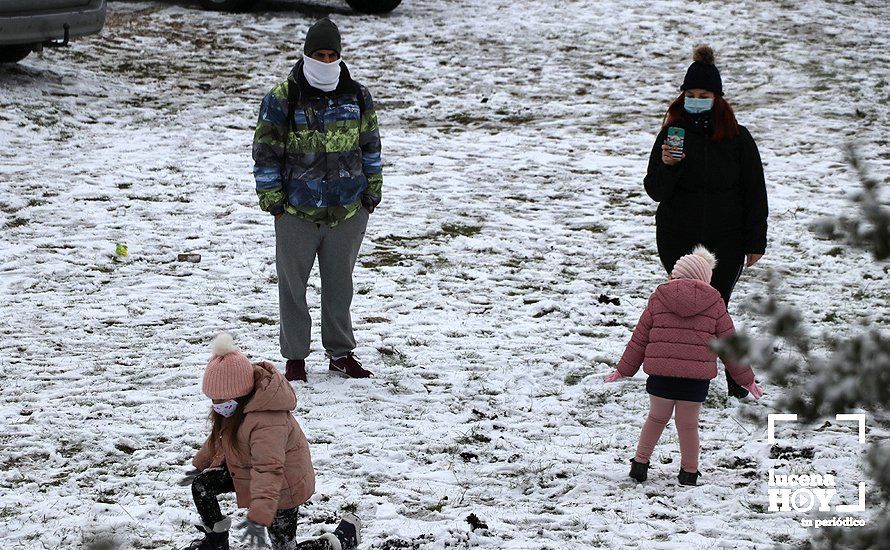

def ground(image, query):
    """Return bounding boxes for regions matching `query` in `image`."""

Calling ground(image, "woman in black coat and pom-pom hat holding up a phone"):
[644,46,767,397]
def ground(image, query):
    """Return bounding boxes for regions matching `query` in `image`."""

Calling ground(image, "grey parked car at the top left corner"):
[0,0,106,63]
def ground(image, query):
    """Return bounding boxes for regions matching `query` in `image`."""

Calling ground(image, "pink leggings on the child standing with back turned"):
[635,395,701,473]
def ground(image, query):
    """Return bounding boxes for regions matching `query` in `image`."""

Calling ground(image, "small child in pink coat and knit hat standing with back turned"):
[605,246,763,485]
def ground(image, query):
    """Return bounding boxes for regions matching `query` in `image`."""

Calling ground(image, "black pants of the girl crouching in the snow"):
[192,466,331,550]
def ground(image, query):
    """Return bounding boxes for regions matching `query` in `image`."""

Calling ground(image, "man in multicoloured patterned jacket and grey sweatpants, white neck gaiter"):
[253,18,383,381]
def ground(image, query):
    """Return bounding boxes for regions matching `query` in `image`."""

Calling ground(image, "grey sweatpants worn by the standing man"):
[275,208,369,359]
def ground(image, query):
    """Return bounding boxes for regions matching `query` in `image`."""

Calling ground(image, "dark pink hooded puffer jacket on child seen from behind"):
[618,279,754,386]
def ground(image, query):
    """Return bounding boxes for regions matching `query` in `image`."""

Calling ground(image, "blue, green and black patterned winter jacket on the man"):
[253,61,383,226]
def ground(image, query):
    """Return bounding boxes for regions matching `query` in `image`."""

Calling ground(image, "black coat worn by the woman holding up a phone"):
[644,120,768,256]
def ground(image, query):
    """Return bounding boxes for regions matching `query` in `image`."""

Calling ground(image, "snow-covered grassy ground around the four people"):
[0,0,890,549]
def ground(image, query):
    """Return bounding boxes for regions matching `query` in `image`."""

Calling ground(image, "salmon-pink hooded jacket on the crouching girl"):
[192,361,315,526]
